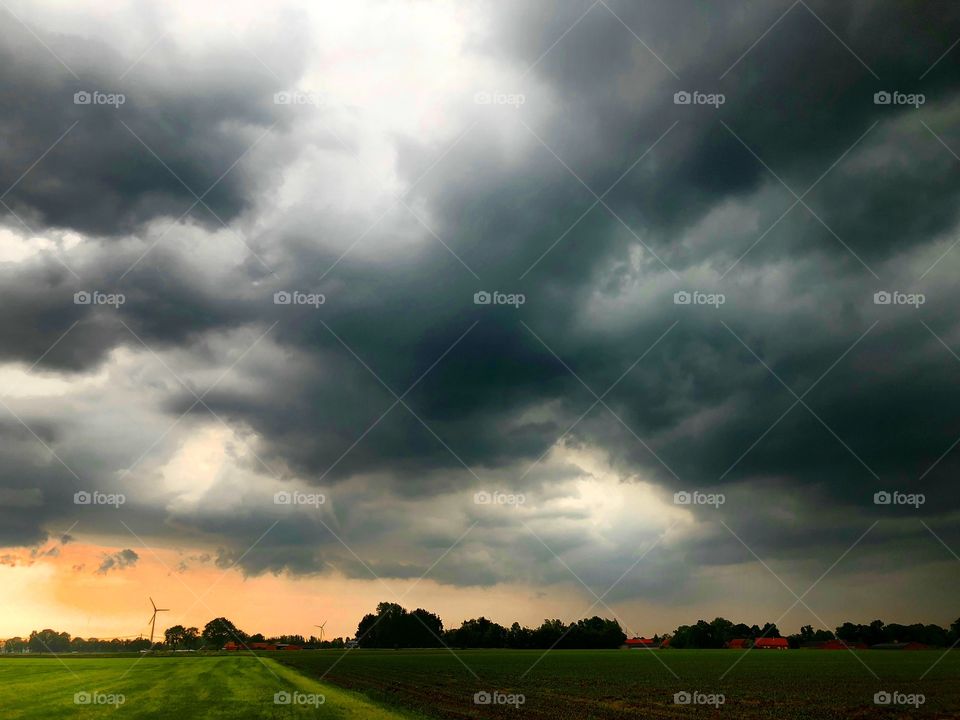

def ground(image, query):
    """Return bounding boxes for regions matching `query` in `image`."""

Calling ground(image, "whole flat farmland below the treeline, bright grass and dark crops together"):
[0,650,960,720]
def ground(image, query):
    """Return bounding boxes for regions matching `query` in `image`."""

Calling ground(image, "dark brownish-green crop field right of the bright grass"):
[279,650,960,720]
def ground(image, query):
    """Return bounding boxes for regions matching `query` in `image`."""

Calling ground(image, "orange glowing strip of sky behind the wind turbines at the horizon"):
[0,542,584,639]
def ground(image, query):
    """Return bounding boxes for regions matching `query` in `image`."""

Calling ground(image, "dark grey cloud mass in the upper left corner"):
[0,12,297,236]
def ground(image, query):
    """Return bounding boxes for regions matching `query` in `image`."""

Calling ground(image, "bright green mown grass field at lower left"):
[0,655,416,720]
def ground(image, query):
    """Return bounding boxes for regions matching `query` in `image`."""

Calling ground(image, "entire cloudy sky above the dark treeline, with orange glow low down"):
[0,0,960,637]
